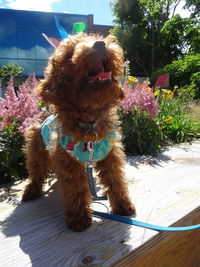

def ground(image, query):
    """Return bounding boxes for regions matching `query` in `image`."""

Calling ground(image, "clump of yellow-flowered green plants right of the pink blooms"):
[155,87,199,144]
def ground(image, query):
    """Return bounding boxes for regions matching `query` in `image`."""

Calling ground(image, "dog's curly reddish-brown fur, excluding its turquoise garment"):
[22,33,135,231]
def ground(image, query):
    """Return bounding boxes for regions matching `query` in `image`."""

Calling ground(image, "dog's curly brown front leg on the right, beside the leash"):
[96,144,135,216]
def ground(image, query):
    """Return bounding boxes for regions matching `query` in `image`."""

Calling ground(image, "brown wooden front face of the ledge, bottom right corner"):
[113,208,200,267]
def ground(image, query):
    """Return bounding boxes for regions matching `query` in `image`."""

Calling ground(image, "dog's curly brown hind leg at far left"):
[22,127,49,201]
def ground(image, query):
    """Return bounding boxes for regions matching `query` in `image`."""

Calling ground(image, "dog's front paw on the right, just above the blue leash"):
[112,200,136,216]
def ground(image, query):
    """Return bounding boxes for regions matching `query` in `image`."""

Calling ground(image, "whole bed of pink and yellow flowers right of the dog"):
[119,76,200,155]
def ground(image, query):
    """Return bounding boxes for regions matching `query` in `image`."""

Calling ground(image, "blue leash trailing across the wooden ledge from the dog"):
[86,165,200,232]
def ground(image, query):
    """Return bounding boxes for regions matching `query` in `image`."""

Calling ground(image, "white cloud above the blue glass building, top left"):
[6,0,60,11]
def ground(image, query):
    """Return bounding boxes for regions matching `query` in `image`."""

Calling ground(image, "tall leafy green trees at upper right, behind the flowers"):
[112,0,199,75]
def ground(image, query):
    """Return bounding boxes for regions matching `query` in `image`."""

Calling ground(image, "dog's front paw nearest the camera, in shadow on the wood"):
[67,214,92,232]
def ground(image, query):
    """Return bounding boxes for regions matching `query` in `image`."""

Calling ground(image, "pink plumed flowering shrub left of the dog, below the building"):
[0,74,42,183]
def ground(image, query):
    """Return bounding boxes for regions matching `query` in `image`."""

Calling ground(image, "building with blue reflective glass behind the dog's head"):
[0,9,112,77]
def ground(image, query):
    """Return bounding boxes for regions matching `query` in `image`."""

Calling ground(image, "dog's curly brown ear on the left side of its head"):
[35,36,79,106]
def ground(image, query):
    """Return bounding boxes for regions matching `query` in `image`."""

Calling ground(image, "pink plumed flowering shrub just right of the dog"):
[120,76,160,155]
